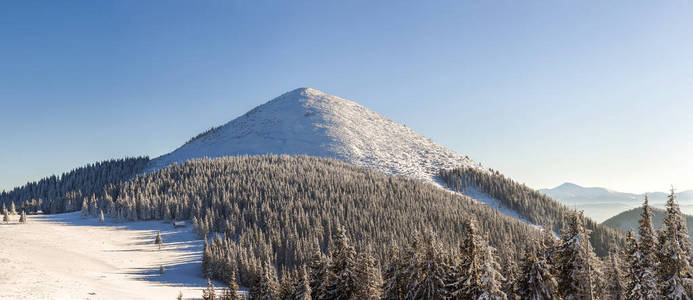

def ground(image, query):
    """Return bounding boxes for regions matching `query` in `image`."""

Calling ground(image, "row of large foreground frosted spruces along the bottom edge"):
[197,191,693,300]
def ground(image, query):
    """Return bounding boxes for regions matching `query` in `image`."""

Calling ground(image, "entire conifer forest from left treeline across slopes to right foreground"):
[2,155,693,299]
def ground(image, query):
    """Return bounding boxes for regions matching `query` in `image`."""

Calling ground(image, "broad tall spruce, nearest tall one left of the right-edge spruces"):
[556,211,600,300]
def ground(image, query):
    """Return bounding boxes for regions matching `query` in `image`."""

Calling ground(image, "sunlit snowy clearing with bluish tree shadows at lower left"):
[0,212,214,300]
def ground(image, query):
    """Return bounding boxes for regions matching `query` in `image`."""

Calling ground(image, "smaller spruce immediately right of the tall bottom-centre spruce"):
[354,245,383,300]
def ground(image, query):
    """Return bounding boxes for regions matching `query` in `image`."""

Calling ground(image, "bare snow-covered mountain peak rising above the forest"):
[148,88,481,181]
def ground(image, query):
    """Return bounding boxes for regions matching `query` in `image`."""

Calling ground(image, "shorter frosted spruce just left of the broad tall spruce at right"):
[517,243,561,300]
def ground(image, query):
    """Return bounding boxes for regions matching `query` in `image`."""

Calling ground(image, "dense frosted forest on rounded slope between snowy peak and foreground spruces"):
[102,155,540,283]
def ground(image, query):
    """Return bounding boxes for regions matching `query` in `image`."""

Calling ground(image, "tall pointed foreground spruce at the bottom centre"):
[320,226,357,299]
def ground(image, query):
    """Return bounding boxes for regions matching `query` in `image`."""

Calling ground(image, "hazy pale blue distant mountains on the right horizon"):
[539,182,693,222]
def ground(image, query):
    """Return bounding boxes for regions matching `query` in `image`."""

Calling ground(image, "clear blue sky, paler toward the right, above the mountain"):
[0,0,693,192]
